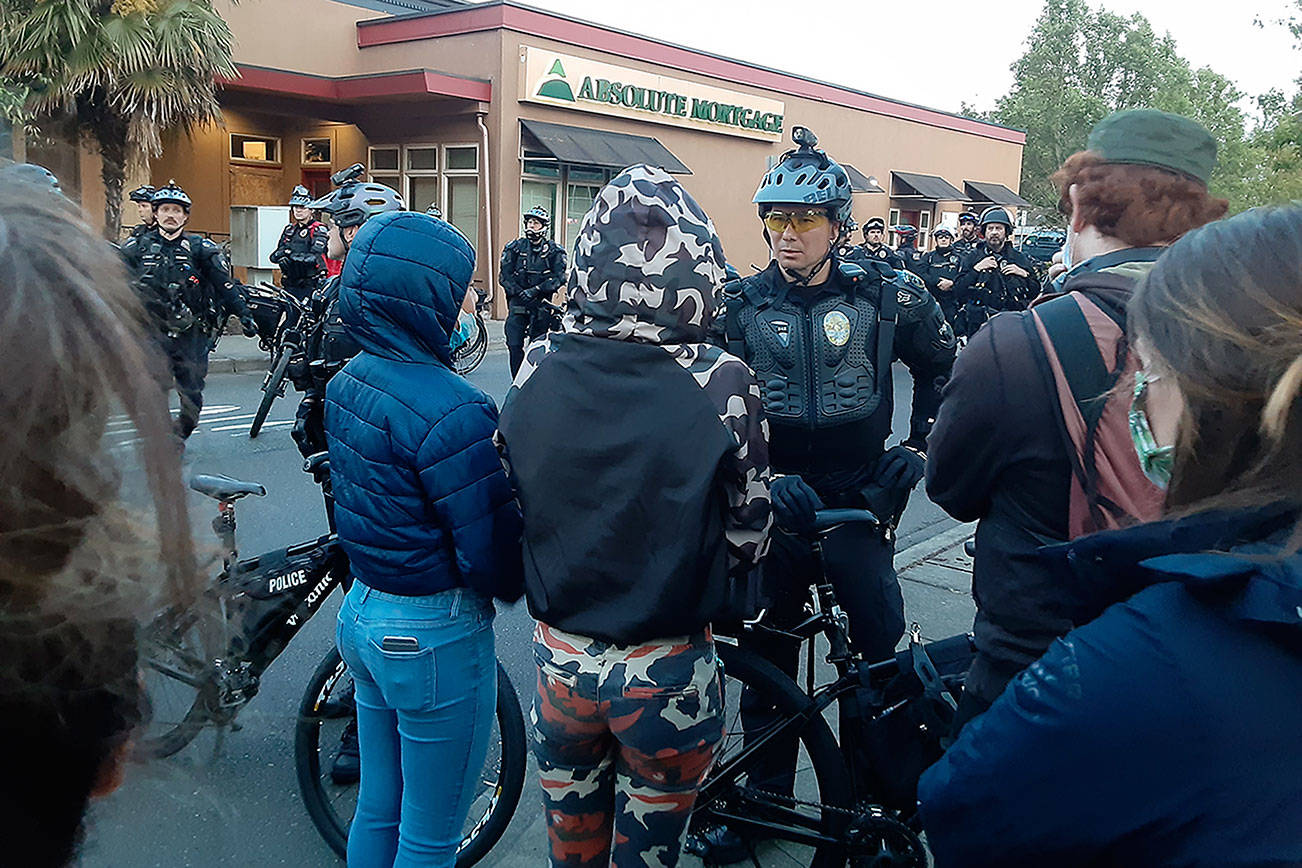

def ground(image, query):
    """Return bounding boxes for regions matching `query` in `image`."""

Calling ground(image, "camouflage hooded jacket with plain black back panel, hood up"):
[499,165,771,644]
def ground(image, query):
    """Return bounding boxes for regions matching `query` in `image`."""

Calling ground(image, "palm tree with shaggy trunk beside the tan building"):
[0,0,238,239]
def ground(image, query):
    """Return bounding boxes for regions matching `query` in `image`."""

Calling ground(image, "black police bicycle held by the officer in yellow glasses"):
[690,509,975,868]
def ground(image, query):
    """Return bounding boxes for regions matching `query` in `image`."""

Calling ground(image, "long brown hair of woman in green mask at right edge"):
[1129,203,1302,537]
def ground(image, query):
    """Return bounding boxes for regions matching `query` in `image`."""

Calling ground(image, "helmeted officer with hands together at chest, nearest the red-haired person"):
[954,206,1038,337]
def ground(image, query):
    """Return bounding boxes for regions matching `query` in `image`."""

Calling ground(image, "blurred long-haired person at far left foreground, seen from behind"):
[0,182,198,868]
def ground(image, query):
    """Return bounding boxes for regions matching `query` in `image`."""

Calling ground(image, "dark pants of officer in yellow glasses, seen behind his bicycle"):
[740,498,904,794]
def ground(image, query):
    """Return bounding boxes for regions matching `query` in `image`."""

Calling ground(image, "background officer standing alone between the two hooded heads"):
[497,206,565,377]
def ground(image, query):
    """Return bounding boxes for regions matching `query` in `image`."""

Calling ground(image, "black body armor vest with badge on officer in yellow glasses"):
[728,263,897,428]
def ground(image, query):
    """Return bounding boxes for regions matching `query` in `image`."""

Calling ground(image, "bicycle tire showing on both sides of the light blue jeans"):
[294,648,527,867]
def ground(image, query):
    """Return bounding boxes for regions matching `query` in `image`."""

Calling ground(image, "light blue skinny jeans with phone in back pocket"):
[335,580,497,868]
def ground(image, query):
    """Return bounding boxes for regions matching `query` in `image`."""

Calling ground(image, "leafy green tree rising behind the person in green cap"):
[987,0,1260,208]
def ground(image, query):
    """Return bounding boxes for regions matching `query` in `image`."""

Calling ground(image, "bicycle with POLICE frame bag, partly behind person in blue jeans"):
[135,453,526,865]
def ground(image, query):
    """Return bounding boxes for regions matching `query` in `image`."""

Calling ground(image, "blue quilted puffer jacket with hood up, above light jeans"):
[326,211,523,601]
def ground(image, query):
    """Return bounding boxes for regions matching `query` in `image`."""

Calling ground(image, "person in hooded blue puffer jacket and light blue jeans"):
[326,212,523,868]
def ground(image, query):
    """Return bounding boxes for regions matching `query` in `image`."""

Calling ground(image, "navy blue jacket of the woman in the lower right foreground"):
[918,506,1302,868]
